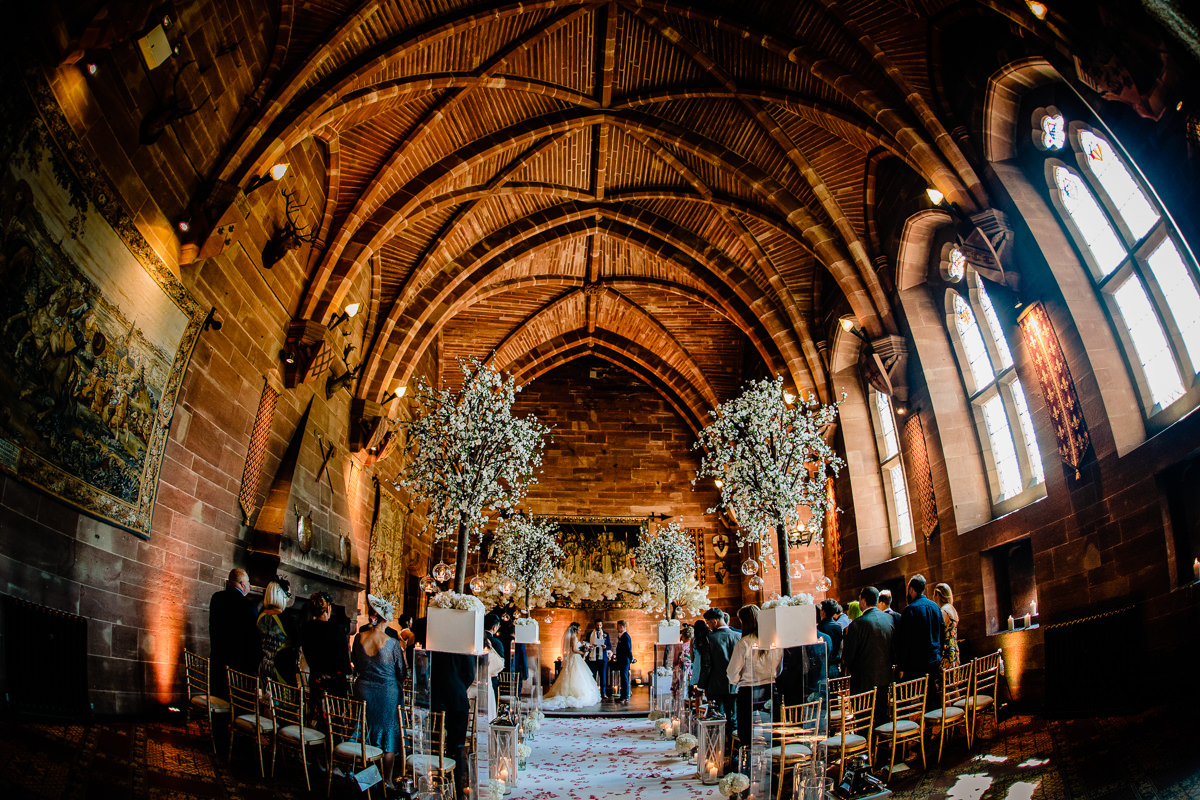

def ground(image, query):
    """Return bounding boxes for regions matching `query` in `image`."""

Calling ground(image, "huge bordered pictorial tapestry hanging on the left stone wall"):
[0,74,205,537]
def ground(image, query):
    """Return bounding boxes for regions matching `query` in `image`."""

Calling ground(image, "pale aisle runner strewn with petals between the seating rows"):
[518,717,721,800]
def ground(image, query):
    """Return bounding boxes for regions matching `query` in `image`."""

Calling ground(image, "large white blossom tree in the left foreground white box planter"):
[398,359,550,593]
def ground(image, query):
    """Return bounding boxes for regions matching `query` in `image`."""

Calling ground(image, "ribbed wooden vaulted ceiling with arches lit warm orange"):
[213,0,986,426]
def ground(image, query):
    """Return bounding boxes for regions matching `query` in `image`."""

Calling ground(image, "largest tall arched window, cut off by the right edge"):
[1036,108,1200,425]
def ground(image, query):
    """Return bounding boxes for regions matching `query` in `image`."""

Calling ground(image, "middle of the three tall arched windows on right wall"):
[942,247,1045,510]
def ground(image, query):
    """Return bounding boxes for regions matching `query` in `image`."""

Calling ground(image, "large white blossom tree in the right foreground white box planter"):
[692,377,845,595]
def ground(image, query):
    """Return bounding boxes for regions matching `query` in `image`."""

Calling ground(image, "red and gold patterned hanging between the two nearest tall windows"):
[1018,302,1091,479]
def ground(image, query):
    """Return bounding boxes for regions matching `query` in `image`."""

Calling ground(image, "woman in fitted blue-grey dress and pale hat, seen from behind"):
[354,595,405,787]
